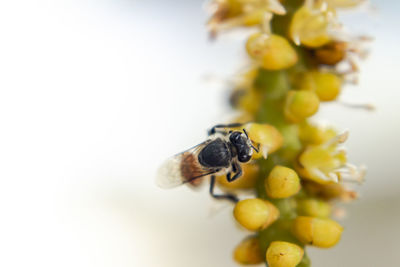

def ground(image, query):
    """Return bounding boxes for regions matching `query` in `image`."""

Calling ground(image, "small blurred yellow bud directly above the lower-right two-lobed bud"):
[297,198,332,218]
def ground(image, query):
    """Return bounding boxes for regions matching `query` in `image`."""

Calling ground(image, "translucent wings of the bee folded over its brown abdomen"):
[156,140,218,188]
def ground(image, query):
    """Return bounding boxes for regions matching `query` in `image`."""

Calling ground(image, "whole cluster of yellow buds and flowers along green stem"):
[209,0,364,267]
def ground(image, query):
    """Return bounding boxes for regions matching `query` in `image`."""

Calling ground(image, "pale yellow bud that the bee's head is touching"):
[244,123,283,159]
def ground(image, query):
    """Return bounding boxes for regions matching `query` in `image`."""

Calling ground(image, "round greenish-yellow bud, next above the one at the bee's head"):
[284,90,319,123]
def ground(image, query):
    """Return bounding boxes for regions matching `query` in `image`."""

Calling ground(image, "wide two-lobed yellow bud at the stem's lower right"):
[293,216,343,248]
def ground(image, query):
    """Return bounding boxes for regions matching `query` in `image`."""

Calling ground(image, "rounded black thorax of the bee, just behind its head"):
[198,138,232,167]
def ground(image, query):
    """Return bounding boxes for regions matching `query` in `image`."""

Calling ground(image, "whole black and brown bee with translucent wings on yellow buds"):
[157,123,258,202]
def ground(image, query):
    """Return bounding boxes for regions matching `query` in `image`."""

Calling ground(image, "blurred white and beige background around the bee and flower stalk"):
[0,0,400,267]
